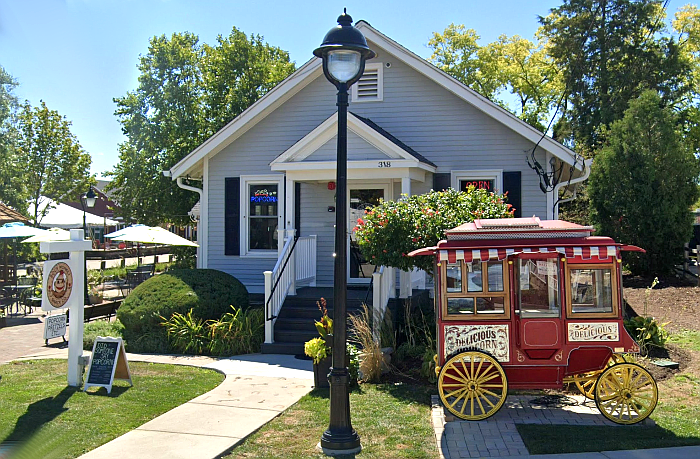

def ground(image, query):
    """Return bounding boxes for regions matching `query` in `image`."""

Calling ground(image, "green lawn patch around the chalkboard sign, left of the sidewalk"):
[0,360,224,459]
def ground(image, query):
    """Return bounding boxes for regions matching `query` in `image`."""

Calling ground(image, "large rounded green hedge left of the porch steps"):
[117,269,248,353]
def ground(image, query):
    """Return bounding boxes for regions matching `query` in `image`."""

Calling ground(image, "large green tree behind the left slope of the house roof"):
[109,27,294,224]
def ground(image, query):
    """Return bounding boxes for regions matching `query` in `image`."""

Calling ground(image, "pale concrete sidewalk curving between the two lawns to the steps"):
[17,349,313,459]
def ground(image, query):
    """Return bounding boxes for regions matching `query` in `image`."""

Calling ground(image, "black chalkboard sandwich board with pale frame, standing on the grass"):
[83,336,134,394]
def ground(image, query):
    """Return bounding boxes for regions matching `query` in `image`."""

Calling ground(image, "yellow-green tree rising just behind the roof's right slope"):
[428,24,563,130]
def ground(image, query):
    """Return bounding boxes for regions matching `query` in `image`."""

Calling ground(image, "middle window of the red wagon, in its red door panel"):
[519,258,559,317]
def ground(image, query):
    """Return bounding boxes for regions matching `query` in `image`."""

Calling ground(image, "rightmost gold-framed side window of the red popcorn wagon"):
[569,267,613,314]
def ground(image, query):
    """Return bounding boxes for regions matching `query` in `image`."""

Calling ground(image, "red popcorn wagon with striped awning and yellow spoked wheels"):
[410,217,658,424]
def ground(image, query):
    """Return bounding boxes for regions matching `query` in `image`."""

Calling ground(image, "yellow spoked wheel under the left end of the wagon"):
[438,351,508,421]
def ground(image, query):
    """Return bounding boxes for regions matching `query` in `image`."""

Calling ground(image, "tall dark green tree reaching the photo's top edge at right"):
[538,0,691,154]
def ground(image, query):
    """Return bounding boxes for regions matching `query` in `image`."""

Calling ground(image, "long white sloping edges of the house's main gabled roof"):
[170,20,583,180]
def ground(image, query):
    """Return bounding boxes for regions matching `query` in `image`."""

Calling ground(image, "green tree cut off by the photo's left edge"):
[0,67,27,214]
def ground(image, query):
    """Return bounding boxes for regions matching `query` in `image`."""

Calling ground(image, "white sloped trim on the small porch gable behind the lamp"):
[270,112,436,172]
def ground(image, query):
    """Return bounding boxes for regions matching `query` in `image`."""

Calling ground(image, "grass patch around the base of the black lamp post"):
[227,384,438,459]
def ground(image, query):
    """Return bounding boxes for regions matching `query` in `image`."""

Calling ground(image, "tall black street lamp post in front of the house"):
[314,11,375,456]
